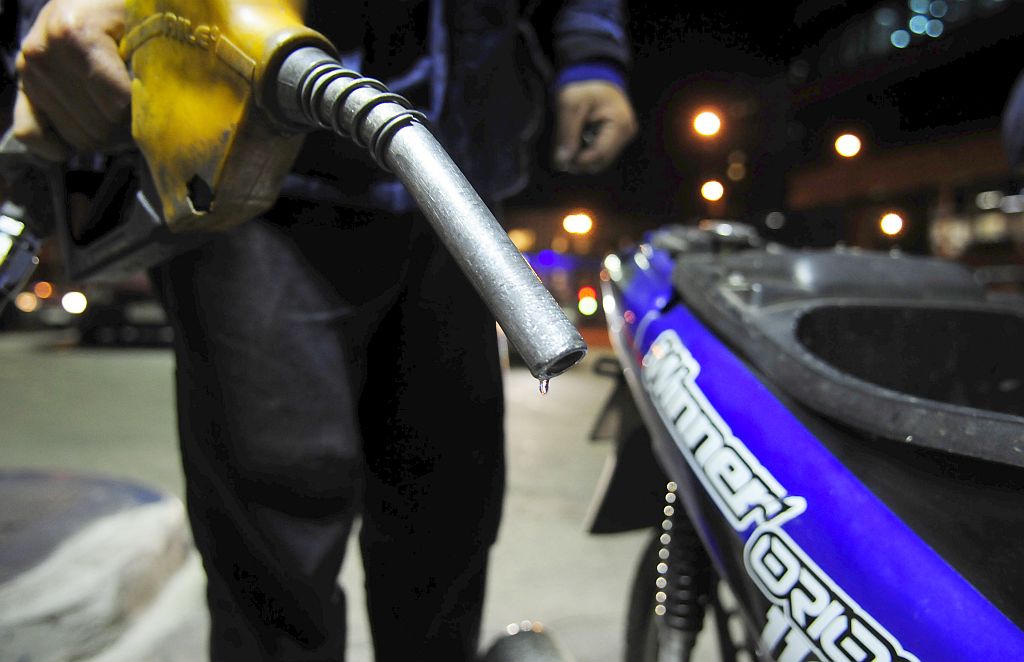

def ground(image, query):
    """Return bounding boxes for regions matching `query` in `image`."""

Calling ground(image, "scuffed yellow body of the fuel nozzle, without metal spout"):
[121,0,334,232]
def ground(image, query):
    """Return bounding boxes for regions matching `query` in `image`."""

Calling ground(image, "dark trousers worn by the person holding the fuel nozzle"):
[154,203,505,662]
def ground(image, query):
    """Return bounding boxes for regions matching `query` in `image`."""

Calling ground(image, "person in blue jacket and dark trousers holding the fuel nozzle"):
[6,0,637,661]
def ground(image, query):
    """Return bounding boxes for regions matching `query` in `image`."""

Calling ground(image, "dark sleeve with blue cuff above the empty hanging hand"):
[553,0,631,71]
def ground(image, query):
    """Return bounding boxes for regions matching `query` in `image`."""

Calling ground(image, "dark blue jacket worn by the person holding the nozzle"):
[0,0,630,211]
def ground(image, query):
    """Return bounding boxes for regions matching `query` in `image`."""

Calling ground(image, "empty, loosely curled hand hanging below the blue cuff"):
[555,80,637,174]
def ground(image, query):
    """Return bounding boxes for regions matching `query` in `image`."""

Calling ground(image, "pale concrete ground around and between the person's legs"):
[0,333,643,662]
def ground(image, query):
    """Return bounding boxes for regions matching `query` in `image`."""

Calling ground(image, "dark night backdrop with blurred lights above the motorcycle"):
[510,0,1024,262]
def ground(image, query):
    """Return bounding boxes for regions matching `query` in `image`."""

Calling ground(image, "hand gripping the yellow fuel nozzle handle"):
[12,0,131,161]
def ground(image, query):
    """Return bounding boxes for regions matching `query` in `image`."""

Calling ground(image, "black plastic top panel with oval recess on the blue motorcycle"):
[674,245,1024,467]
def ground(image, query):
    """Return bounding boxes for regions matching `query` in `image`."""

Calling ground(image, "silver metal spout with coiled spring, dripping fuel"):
[274,47,587,380]
